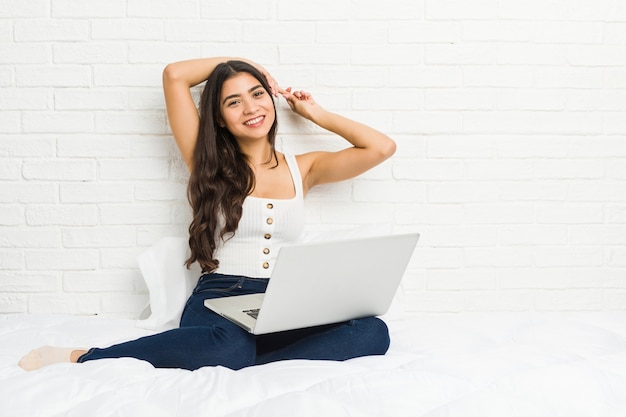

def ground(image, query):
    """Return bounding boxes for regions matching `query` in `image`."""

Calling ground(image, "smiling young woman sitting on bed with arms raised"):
[20,57,395,370]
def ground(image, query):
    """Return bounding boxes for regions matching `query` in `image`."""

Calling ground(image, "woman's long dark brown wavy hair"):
[185,61,278,272]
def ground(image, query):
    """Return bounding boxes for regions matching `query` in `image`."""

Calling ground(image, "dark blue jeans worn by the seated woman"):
[78,274,389,370]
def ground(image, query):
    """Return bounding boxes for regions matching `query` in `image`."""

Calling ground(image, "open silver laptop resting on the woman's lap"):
[204,233,419,334]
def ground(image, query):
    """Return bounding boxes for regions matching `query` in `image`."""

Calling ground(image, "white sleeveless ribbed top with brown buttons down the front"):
[214,155,304,278]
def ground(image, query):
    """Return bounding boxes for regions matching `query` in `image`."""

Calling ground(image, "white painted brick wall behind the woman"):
[0,0,626,317]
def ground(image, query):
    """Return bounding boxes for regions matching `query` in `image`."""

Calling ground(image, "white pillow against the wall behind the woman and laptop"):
[137,225,404,330]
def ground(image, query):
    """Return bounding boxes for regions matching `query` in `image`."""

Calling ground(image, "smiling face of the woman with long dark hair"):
[220,72,276,146]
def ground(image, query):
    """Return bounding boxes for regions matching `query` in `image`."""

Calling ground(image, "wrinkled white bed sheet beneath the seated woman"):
[0,312,626,417]
